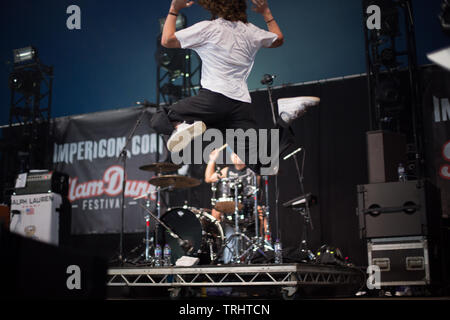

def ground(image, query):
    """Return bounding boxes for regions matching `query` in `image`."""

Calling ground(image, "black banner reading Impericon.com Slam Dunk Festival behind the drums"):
[53,108,167,234]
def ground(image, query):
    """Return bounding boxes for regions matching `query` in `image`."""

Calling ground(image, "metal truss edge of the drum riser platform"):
[107,263,365,288]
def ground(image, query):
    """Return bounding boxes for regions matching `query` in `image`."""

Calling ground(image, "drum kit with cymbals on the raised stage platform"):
[134,162,273,265]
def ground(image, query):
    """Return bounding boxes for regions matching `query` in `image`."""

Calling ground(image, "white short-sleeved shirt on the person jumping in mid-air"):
[175,18,278,103]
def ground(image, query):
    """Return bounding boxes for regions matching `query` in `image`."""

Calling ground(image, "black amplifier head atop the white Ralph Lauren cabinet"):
[14,170,69,197]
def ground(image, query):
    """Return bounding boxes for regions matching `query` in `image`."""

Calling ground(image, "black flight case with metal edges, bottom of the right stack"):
[367,237,431,286]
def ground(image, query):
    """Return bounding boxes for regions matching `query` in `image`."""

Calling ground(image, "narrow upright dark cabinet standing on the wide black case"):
[367,131,407,183]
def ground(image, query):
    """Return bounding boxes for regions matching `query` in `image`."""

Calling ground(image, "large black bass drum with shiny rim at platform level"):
[161,208,225,264]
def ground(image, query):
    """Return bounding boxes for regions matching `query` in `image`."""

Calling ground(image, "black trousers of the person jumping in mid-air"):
[150,89,294,173]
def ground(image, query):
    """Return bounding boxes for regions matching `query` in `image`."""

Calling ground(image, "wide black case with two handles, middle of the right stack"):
[357,180,427,238]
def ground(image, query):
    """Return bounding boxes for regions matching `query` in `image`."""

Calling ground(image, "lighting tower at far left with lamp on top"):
[1,46,53,201]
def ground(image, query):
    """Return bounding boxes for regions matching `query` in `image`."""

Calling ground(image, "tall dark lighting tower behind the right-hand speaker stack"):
[362,0,423,177]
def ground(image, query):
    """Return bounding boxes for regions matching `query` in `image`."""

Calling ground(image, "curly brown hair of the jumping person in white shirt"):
[198,0,248,23]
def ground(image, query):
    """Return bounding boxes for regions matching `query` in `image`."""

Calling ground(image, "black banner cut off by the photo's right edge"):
[423,67,450,218]
